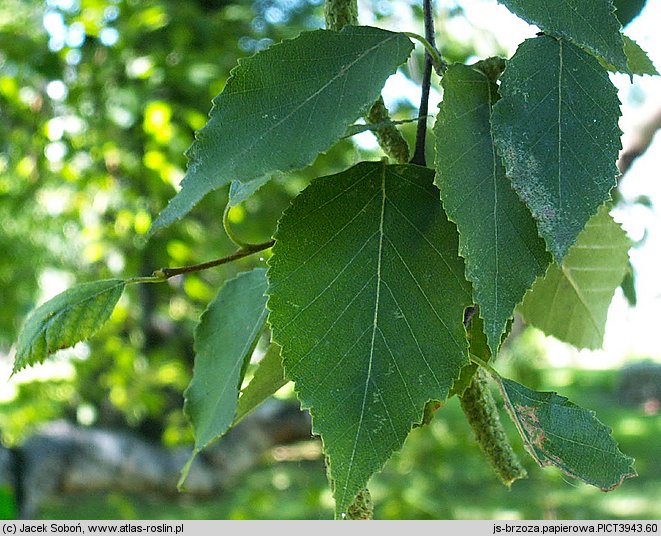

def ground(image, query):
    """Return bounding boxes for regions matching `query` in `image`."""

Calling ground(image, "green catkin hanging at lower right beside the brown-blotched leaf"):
[459,369,527,487]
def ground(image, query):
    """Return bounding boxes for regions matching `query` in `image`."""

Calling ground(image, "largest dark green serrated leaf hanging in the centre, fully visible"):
[268,162,471,514]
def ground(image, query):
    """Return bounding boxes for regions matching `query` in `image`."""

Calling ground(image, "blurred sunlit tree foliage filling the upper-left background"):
[0,0,497,445]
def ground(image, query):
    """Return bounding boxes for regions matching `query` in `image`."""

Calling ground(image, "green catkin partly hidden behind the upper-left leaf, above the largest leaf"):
[324,0,409,164]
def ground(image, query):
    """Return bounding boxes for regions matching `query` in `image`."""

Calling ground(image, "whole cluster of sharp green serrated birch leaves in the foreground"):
[11,0,653,513]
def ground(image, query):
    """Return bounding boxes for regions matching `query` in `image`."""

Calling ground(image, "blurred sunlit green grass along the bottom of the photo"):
[34,367,661,520]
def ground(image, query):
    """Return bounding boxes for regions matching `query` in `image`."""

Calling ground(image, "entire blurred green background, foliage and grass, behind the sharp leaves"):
[0,0,661,519]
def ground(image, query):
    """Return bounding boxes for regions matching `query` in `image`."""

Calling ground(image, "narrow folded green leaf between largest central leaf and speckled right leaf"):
[434,65,550,353]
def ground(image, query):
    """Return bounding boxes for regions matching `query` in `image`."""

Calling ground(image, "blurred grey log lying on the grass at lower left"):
[0,400,312,519]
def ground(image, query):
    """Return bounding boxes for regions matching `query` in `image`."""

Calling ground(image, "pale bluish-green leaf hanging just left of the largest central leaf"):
[184,268,267,457]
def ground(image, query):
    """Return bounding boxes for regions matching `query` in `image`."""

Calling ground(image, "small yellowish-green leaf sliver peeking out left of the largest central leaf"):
[233,343,288,425]
